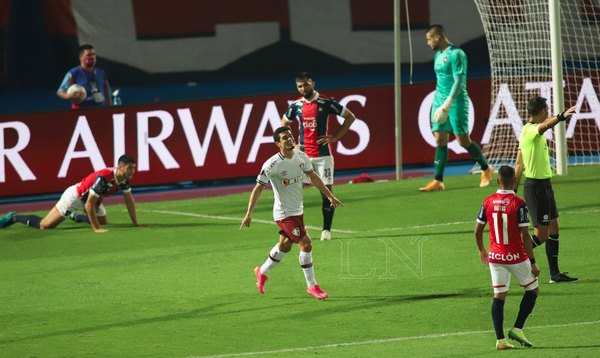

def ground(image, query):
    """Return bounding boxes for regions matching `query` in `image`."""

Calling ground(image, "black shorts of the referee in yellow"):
[524,178,558,227]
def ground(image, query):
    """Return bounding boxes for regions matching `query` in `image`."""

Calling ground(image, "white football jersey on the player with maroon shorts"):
[256,150,313,221]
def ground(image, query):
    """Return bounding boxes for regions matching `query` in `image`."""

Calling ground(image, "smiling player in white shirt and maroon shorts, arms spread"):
[240,127,342,300]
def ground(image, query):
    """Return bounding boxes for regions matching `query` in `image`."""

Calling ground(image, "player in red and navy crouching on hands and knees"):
[0,155,140,233]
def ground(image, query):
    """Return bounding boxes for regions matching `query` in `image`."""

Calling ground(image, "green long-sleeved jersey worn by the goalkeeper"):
[433,44,467,108]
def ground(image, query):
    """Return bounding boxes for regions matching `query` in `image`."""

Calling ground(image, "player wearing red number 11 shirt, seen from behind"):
[475,166,540,350]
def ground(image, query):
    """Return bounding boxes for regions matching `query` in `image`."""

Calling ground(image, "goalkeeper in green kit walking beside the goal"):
[419,25,494,191]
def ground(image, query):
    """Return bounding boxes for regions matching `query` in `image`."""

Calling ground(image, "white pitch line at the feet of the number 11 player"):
[193,320,600,358]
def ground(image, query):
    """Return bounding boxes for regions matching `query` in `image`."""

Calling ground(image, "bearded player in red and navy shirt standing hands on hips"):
[281,72,356,240]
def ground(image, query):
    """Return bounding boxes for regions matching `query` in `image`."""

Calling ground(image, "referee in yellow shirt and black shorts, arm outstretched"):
[515,97,577,283]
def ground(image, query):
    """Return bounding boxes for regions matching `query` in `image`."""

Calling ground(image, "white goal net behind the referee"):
[474,0,600,170]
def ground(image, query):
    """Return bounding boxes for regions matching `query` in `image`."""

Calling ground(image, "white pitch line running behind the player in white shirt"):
[137,209,600,234]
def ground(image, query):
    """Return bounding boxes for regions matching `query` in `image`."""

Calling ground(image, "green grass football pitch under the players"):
[0,166,600,357]
